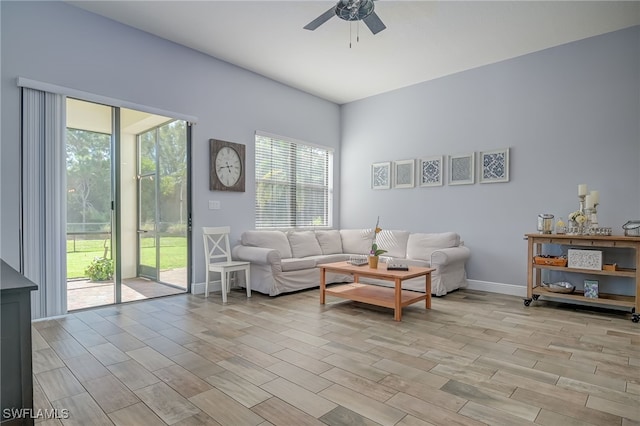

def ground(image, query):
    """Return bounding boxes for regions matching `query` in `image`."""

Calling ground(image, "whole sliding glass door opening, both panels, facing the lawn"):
[66,99,190,310]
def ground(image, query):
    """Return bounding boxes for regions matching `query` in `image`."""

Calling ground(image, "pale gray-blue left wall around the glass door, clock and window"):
[0,1,340,282]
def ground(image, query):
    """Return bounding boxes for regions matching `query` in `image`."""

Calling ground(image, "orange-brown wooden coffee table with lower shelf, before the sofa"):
[318,262,435,321]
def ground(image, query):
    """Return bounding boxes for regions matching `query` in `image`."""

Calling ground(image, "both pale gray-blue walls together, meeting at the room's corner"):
[0,1,640,292]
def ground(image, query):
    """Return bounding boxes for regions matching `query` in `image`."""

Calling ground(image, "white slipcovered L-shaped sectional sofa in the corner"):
[232,229,470,296]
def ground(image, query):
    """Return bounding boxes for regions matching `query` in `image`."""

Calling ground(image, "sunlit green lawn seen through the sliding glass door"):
[67,237,187,279]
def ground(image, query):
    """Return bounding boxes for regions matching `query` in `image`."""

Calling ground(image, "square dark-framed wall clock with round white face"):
[209,139,245,192]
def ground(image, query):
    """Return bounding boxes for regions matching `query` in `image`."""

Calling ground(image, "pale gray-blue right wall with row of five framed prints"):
[340,27,640,292]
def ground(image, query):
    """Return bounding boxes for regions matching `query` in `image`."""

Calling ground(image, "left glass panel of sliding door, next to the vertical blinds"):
[66,99,120,310]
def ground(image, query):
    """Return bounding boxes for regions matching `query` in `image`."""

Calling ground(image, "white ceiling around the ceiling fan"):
[68,0,640,104]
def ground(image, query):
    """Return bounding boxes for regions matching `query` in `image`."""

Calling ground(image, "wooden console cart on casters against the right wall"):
[524,234,640,323]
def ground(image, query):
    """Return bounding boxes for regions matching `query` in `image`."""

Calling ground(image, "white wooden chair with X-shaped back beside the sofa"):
[202,226,251,303]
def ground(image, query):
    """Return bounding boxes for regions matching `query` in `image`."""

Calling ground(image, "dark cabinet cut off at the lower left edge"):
[0,260,38,425]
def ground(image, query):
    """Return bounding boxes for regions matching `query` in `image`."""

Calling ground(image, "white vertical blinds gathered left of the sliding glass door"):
[20,87,67,319]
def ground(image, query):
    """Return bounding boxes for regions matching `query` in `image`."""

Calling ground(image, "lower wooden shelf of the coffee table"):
[325,283,427,309]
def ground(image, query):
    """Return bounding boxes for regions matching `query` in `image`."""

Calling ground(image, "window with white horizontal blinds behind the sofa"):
[255,133,333,229]
